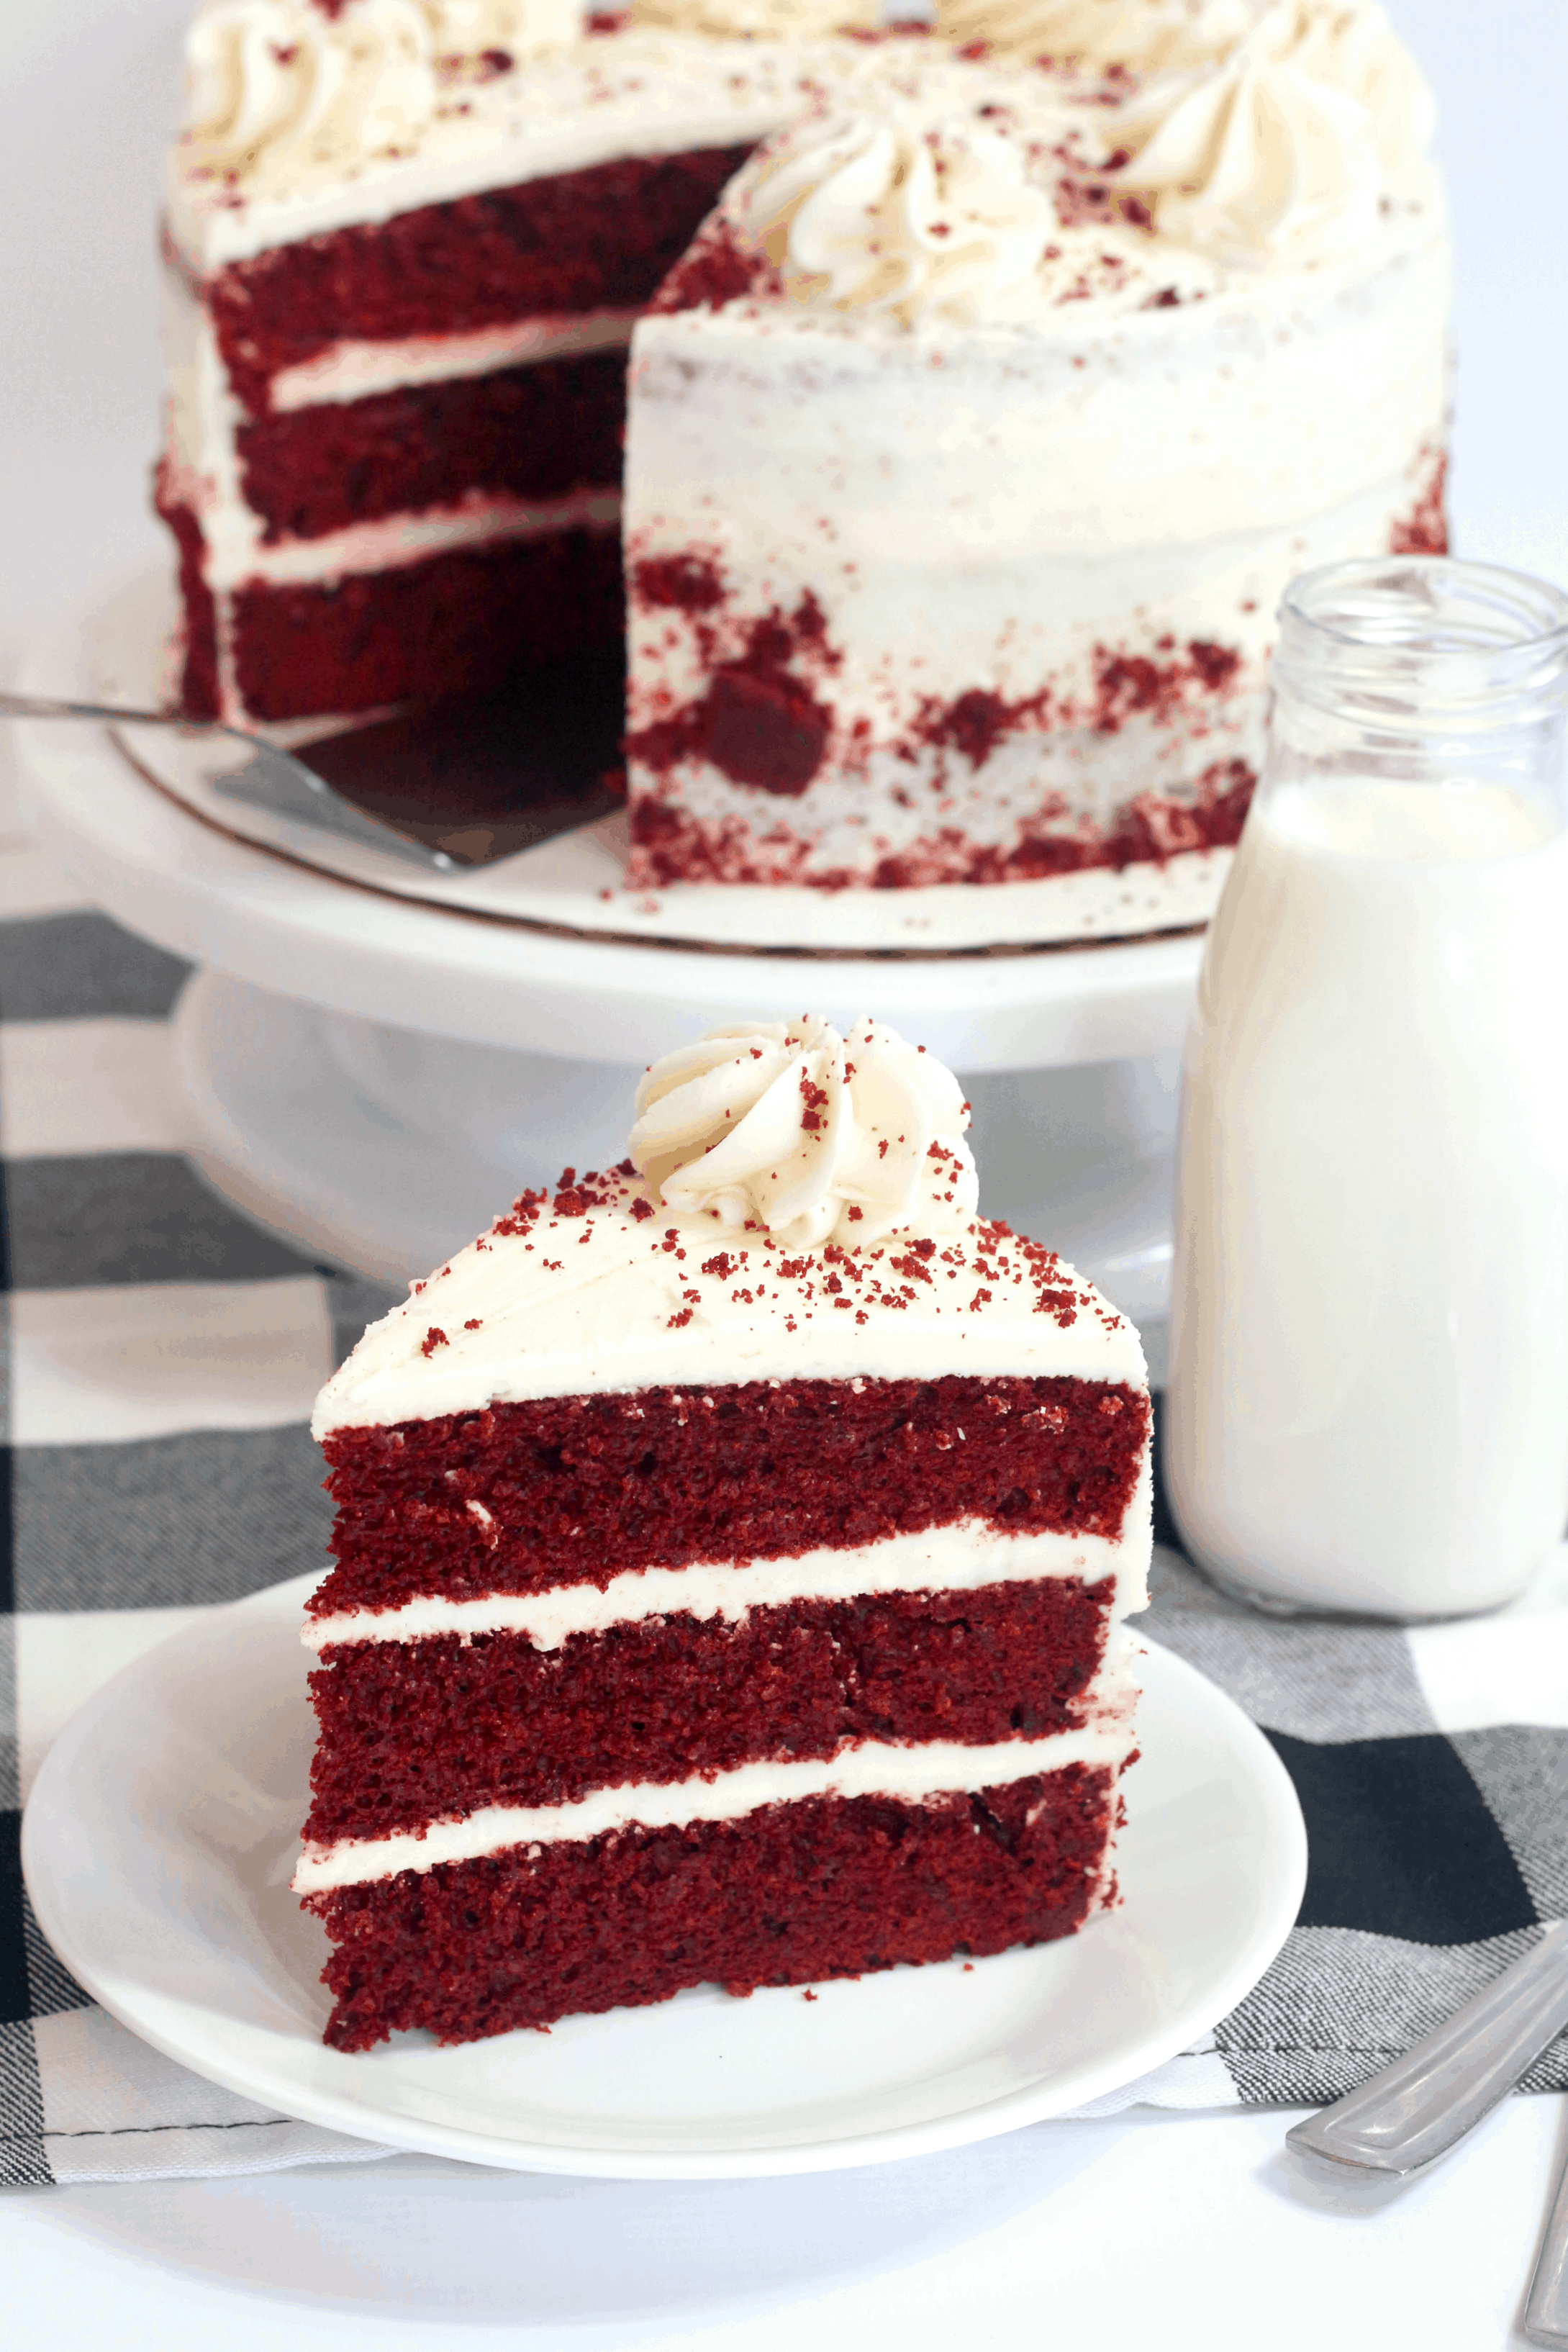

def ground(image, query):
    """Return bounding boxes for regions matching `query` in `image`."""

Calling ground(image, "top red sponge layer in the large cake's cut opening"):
[204,146,750,416]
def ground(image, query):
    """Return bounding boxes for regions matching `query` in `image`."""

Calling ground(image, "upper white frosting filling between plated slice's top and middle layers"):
[303,1491,1149,1653]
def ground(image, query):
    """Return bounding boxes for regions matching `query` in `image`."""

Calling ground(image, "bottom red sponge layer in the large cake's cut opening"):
[230,529,623,720]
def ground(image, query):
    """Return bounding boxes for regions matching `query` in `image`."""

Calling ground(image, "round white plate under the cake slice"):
[21,1576,1307,2180]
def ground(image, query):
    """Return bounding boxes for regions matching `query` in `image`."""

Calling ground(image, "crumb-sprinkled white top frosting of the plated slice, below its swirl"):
[312,1174,1145,1444]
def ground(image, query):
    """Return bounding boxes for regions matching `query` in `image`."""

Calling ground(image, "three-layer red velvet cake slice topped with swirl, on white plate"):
[294,1018,1149,2051]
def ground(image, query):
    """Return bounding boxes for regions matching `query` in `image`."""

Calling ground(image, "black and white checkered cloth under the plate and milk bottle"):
[0,840,1568,2183]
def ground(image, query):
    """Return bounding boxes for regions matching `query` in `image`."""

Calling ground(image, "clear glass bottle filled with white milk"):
[1166,558,1568,1618]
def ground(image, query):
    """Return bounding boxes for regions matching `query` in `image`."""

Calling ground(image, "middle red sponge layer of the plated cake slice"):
[306,1576,1114,1844]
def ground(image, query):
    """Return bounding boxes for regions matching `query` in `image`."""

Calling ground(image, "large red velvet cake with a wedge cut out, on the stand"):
[158,0,1448,948]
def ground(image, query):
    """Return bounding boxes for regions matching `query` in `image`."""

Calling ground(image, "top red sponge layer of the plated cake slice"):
[320,1373,1147,1616]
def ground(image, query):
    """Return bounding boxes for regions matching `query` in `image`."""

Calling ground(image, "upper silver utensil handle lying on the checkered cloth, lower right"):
[1286,1922,1568,2178]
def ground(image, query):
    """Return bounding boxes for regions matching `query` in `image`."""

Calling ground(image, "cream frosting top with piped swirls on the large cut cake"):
[171,0,1432,279]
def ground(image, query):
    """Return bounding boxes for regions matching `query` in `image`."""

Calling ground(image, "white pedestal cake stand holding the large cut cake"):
[19,583,1201,1317]
